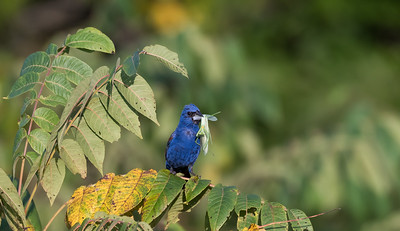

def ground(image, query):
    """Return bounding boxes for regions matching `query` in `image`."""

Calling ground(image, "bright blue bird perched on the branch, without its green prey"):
[165,104,203,177]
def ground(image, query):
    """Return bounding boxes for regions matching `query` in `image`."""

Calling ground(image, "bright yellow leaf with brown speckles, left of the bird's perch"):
[66,169,157,226]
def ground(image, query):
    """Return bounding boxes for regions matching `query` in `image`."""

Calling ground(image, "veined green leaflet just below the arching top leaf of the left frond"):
[52,55,93,85]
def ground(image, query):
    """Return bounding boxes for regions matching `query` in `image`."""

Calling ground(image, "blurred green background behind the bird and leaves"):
[0,0,400,231]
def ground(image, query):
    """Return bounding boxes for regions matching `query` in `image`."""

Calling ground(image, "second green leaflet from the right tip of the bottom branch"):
[261,202,288,230]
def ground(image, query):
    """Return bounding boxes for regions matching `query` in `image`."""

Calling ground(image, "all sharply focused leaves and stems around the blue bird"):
[0,27,318,230]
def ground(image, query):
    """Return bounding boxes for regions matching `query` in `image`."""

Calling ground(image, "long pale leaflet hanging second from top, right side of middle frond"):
[98,87,142,139]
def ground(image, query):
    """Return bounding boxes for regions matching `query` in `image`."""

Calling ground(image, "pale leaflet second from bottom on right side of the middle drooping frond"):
[60,139,87,178]
